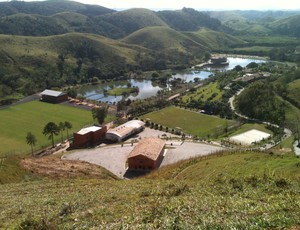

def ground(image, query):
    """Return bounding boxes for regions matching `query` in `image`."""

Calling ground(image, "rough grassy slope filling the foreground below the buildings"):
[0,152,300,229]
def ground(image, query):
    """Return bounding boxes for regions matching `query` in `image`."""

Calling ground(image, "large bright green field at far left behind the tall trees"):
[0,101,93,156]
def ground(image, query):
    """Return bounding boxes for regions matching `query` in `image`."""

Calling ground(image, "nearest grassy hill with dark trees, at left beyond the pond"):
[0,33,146,99]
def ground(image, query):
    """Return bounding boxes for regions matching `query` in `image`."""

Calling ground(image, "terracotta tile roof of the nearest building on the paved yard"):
[128,137,166,160]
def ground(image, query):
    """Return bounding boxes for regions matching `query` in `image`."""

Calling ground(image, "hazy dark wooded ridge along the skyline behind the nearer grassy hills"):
[0,1,224,39]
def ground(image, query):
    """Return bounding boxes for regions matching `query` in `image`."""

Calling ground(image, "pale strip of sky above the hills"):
[0,0,300,10]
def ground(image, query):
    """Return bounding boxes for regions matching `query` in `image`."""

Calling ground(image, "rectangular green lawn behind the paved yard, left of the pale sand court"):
[141,106,235,137]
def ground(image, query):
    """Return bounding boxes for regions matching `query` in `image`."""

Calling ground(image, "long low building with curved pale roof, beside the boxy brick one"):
[105,120,145,142]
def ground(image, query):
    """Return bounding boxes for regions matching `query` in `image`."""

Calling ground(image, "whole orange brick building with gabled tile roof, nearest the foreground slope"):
[128,138,166,170]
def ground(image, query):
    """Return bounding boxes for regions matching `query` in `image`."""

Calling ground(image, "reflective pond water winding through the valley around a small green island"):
[78,57,266,103]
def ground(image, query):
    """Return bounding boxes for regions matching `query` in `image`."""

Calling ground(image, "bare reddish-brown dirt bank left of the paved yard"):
[21,156,114,179]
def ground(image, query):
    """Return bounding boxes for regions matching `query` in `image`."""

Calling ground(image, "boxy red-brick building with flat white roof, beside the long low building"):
[73,126,107,148]
